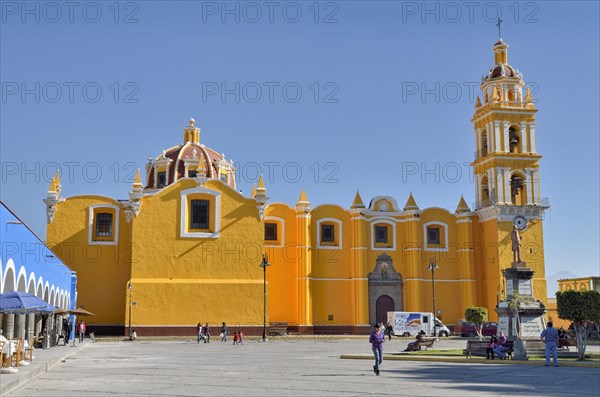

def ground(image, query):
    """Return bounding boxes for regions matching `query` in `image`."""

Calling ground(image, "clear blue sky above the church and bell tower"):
[0,1,600,289]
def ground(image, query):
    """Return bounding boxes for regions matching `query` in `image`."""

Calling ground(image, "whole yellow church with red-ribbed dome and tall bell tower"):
[44,40,548,335]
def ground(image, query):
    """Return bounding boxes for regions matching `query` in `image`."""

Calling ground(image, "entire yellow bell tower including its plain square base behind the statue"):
[471,39,549,307]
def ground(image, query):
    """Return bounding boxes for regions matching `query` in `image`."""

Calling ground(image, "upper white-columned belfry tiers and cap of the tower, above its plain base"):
[471,39,542,209]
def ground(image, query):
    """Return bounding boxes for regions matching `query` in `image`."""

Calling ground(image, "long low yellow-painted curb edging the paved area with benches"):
[340,354,600,368]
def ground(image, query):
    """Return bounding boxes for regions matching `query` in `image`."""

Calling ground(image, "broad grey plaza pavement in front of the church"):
[0,337,600,397]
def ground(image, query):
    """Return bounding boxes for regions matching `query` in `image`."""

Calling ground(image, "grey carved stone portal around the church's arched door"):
[367,253,404,325]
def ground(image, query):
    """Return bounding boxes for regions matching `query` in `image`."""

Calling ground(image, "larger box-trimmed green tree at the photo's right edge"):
[556,291,600,360]
